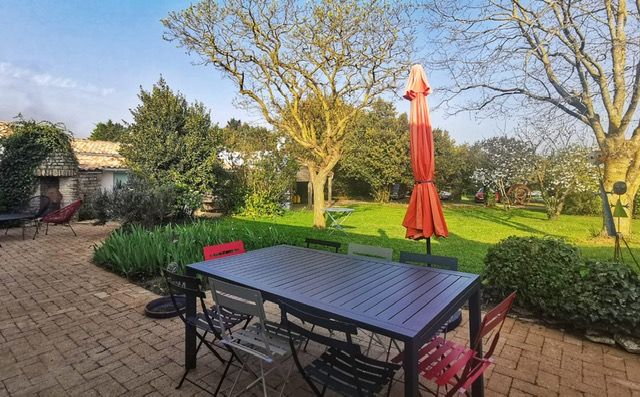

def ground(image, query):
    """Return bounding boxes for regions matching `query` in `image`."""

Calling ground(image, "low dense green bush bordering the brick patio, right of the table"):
[484,237,640,335]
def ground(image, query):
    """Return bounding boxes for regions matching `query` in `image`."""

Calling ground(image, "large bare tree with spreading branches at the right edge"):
[426,0,640,232]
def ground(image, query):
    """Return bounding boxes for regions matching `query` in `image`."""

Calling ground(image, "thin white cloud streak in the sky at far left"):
[0,62,115,96]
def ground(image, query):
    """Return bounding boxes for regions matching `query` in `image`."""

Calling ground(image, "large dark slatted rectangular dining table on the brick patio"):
[185,245,484,396]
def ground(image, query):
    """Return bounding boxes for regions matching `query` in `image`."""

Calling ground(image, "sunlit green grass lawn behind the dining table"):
[231,203,640,273]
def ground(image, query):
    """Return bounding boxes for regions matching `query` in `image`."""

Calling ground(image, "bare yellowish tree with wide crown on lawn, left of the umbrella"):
[163,0,414,227]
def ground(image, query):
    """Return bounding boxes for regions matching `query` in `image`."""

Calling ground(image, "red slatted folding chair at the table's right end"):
[392,292,516,396]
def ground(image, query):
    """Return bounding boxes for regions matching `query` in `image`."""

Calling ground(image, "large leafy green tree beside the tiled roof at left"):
[121,78,220,201]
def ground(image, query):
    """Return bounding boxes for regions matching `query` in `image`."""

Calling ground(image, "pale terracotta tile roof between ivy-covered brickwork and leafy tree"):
[71,139,127,170]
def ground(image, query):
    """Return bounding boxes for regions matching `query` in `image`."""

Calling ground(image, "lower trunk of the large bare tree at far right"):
[603,156,638,236]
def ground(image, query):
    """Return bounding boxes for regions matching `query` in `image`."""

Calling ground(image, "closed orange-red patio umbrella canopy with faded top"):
[402,65,449,240]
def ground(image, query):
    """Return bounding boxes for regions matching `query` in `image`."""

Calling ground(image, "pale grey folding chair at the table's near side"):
[209,278,300,396]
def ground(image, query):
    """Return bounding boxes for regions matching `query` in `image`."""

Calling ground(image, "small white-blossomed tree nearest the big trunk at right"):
[534,145,598,219]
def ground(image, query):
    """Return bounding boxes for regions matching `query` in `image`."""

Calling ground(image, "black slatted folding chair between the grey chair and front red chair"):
[280,301,400,396]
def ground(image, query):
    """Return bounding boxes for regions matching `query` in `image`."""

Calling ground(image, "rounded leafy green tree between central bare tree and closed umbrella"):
[339,100,411,202]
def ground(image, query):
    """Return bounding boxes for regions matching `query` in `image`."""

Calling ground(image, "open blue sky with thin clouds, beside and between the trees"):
[0,0,502,142]
